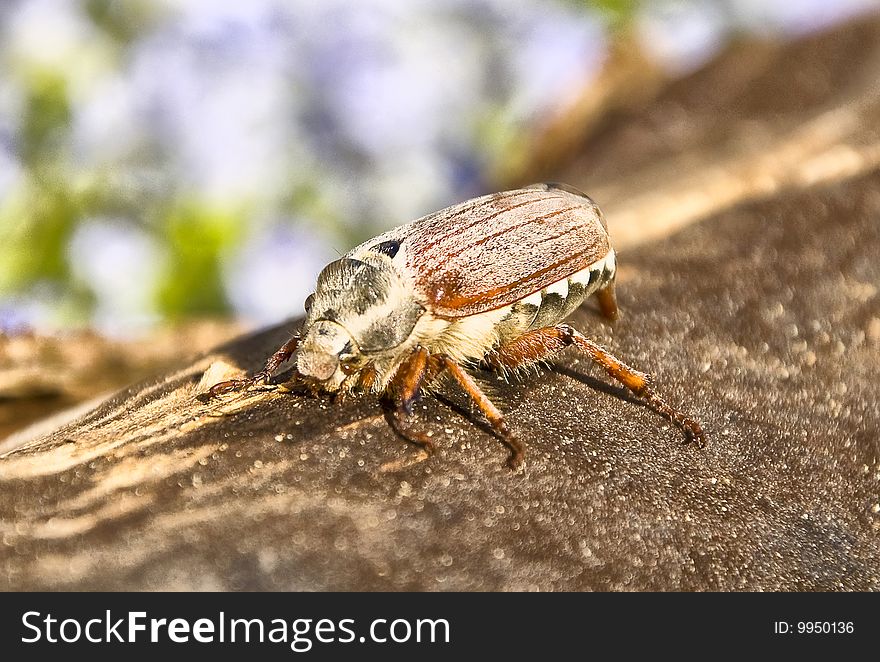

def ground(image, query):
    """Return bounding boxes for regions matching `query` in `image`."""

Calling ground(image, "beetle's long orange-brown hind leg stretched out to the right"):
[487,324,706,448]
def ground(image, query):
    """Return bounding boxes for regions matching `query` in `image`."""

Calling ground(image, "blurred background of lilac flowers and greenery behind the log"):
[0,0,878,435]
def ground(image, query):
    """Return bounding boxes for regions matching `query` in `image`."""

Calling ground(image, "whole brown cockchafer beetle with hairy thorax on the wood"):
[209,183,705,469]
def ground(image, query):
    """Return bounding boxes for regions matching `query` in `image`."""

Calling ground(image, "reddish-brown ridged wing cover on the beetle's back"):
[369,184,611,319]
